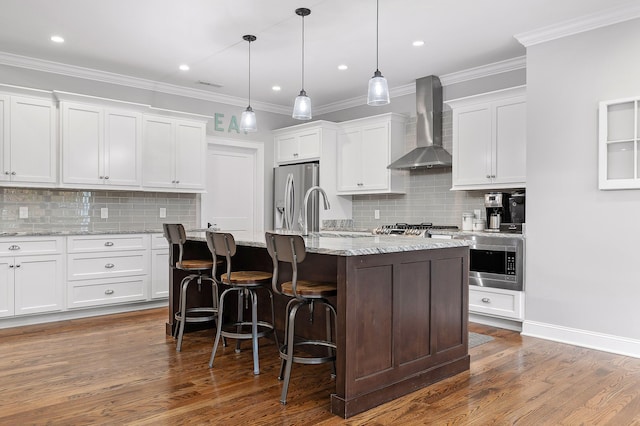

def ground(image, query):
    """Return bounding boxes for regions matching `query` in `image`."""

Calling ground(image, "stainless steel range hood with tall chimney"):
[387,75,451,169]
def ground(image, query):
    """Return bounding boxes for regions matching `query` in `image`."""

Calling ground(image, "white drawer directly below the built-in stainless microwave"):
[469,286,523,319]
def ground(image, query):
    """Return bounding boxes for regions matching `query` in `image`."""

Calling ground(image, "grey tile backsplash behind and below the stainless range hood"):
[352,109,486,229]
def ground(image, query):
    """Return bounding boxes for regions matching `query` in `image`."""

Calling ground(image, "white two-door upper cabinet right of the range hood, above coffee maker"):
[447,87,526,190]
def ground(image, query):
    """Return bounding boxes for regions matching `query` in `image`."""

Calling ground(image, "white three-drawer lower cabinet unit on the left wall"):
[67,235,150,308]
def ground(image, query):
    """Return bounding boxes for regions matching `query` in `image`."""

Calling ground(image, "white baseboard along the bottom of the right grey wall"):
[522,321,640,358]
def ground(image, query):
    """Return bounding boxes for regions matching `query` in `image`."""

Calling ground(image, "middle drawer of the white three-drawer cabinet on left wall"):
[67,250,149,281]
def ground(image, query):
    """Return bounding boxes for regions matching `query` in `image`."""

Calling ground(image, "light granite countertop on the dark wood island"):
[187,231,469,256]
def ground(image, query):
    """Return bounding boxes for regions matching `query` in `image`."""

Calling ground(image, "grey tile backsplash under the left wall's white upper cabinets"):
[0,188,200,232]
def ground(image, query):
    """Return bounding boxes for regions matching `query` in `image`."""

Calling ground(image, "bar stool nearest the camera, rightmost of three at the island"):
[265,232,338,404]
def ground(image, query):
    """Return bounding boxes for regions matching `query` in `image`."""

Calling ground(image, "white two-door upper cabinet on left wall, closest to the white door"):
[143,115,206,192]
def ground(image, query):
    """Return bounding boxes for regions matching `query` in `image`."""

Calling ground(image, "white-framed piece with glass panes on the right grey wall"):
[598,98,640,189]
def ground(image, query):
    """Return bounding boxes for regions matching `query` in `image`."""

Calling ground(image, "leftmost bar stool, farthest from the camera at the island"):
[162,223,218,352]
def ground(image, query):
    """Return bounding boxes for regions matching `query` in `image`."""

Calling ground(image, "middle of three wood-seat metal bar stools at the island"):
[207,232,278,375]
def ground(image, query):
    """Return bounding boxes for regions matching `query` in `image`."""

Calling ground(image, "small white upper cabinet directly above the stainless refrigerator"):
[275,124,322,164]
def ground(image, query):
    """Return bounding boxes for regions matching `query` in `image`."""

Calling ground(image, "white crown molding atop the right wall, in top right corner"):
[514,1,640,47]
